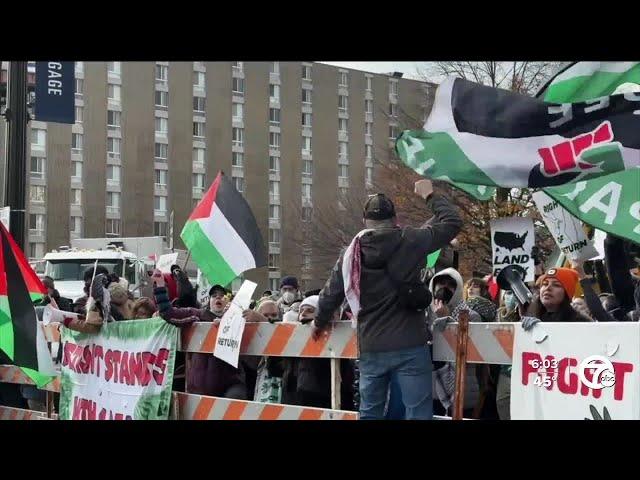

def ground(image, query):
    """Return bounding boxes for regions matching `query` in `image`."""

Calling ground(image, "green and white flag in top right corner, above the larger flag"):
[541,62,640,103]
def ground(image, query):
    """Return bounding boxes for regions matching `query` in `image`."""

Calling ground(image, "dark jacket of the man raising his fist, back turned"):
[316,195,462,352]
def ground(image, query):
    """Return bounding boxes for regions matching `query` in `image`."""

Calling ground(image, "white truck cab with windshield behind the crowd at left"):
[44,247,145,302]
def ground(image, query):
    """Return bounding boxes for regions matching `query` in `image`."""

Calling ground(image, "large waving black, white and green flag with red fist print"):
[396,78,640,188]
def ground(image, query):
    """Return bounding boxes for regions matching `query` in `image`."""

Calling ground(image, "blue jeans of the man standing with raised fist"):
[358,345,433,420]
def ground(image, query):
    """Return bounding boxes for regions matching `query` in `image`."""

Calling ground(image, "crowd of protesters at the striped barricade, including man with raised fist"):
[0,180,640,419]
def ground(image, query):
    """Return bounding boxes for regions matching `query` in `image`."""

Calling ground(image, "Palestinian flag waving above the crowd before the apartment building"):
[180,172,267,285]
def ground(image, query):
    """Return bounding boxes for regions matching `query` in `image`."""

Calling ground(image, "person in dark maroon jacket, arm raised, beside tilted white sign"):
[151,269,247,400]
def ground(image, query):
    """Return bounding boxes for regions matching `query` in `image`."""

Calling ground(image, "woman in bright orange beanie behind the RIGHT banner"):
[523,268,591,322]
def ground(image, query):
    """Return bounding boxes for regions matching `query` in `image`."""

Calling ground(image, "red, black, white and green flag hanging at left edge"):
[0,224,56,387]
